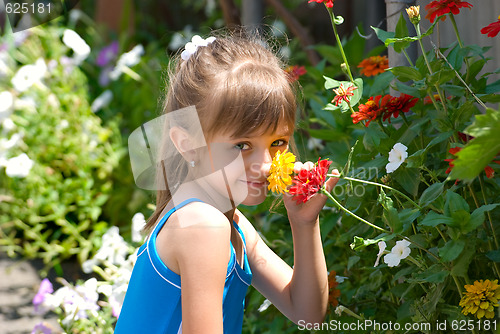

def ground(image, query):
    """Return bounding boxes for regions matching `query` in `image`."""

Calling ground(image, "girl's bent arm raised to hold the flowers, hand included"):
[241,174,338,323]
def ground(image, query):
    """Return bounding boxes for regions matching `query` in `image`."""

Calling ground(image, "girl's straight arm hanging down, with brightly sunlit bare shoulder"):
[159,203,231,334]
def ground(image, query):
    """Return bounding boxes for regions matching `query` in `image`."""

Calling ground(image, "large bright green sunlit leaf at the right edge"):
[449,109,500,181]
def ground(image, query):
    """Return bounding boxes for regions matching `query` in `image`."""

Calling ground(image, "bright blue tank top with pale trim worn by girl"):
[115,198,252,334]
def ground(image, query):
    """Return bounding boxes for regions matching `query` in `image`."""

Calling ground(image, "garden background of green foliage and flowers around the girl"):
[0,0,500,333]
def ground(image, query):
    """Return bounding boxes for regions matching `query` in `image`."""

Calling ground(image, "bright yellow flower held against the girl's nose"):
[267,151,295,194]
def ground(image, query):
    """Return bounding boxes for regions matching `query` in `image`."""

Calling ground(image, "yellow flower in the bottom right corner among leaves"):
[459,279,500,319]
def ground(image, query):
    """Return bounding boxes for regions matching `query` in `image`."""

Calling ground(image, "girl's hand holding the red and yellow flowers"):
[283,161,340,224]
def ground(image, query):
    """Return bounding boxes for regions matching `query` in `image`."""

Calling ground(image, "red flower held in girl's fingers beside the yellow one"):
[288,159,332,204]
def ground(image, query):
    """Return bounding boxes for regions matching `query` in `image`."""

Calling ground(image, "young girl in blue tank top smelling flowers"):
[115,32,338,334]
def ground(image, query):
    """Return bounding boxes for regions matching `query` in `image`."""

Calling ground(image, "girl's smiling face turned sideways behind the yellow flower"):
[200,126,291,206]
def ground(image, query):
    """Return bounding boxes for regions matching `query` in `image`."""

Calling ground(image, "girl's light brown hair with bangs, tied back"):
[145,34,296,230]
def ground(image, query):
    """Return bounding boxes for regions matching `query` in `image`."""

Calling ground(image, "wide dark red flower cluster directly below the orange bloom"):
[351,94,418,126]
